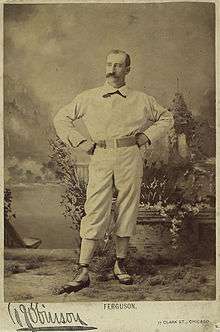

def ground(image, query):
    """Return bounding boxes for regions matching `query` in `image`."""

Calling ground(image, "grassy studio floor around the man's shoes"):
[4,249,216,303]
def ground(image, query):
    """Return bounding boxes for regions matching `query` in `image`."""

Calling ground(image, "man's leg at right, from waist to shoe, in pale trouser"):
[113,146,143,285]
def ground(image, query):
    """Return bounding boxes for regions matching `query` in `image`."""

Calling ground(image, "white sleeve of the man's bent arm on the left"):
[54,97,94,152]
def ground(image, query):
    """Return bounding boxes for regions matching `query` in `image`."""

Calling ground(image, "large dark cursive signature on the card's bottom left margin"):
[8,303,97,332]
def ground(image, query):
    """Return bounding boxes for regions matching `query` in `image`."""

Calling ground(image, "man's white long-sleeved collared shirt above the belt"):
[54,82,173,147]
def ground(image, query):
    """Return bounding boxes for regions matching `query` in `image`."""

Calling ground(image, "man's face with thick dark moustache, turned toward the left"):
[106,53,130,84]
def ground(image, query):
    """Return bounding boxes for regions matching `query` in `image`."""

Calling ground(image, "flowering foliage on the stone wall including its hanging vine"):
[141,163,215,248]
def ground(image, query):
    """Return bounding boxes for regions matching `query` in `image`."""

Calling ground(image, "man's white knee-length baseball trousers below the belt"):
[80,145,143,240]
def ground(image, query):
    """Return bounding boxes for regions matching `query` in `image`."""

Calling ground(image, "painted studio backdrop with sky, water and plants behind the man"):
[4,3,215,300]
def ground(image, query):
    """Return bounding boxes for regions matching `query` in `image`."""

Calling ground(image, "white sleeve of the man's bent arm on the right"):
[143,97,174,144]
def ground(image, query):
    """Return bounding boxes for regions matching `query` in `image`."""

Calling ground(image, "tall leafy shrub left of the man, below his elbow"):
[50,137,86,230]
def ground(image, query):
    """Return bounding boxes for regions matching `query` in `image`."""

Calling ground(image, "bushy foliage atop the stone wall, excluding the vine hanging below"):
[140,162,214,205]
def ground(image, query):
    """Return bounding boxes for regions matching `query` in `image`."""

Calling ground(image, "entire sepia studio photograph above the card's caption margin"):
[3,2,216,304]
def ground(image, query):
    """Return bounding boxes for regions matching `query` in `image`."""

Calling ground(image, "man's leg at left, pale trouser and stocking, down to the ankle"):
[80,150,113,264]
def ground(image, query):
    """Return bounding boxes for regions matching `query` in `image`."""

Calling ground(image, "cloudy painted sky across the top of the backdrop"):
[4,3,215,114]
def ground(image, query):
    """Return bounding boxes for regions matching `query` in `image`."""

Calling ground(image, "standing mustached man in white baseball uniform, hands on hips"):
[54,50,173,293]
